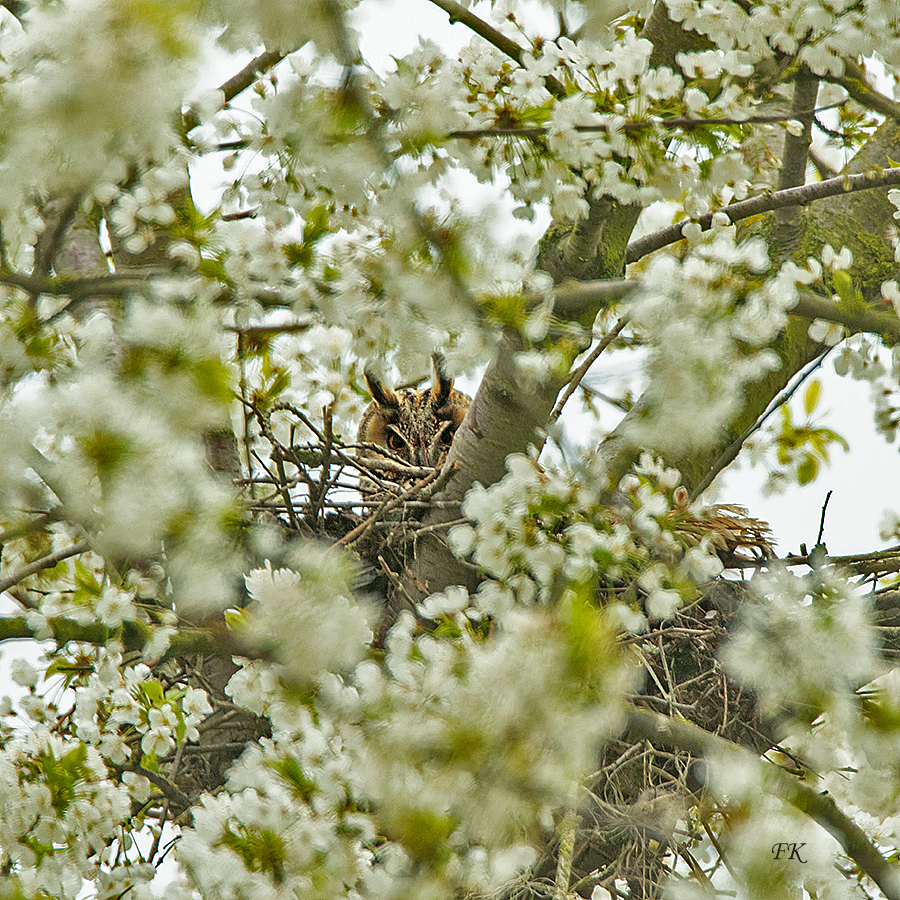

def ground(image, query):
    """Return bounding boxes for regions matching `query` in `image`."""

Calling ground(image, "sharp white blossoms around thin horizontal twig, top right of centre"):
[448,24,758,219]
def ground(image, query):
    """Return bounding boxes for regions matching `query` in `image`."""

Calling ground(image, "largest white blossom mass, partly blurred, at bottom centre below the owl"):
[170,588,632,897]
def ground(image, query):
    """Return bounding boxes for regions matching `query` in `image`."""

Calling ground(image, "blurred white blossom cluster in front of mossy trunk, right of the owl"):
[632,228,801,453]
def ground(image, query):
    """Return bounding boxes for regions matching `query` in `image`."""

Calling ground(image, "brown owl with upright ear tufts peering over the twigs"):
[357,356,472,488]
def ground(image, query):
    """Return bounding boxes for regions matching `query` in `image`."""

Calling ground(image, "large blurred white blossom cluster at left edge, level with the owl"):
[0,302,243,606]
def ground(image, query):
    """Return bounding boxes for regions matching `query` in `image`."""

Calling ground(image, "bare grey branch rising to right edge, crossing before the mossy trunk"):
[626,166,900,263]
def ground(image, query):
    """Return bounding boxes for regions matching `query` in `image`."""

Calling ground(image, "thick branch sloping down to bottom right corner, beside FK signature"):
[626,707,900,900]
